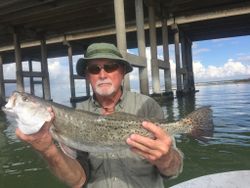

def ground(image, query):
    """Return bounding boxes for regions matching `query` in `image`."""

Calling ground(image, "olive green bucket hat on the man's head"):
[76,43,133,76]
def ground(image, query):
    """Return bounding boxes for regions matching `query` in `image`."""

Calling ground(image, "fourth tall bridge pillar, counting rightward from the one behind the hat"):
[162,16,172,93]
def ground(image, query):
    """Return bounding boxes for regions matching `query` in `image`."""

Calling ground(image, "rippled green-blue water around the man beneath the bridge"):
[0,83,250,188]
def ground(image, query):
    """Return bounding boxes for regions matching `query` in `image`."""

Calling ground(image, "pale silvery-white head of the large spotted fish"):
[2,91,51,134]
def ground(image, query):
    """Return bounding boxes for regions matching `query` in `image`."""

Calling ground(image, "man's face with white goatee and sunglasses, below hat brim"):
[86,59,125,96]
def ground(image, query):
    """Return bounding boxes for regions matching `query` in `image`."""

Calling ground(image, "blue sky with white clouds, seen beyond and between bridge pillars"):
[4,36,250,102]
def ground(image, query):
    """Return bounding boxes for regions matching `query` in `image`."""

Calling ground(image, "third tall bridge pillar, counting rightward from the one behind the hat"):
[148,1,161,94]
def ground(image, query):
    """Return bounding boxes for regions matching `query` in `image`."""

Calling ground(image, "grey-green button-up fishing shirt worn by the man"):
[61,91,181,188]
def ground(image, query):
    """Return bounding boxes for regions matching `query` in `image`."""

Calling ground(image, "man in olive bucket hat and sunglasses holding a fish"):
[16,43,183,188]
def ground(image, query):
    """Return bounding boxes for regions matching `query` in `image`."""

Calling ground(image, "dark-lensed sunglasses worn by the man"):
[86,63,119,74]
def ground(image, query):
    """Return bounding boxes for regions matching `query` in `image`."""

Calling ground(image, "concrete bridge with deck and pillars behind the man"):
[0,0,250,101]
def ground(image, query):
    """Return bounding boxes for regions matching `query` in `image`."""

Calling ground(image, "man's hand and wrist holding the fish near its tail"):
[127,122,182,176]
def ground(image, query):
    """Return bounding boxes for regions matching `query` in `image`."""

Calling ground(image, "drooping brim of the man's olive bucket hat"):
[76,55,133,76]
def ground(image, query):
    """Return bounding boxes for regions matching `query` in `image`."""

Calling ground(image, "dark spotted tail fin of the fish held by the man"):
[181,106,214,140]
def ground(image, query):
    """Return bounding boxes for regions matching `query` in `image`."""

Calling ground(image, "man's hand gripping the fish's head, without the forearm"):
[16,108,55,153]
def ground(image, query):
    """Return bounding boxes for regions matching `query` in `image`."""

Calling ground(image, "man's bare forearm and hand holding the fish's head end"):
[16,108,86,187]
